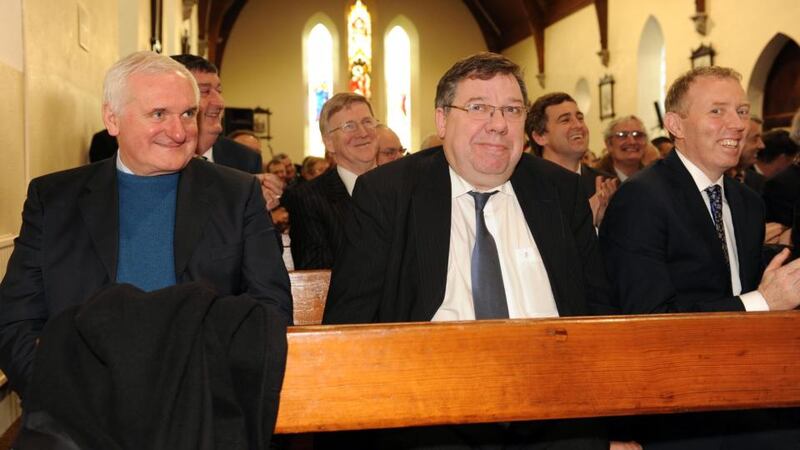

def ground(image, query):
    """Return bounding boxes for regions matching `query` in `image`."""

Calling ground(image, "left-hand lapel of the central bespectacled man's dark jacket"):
[411,150,452,320]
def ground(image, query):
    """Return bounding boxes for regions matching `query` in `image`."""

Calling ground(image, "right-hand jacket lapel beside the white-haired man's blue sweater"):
[174,159,214,280]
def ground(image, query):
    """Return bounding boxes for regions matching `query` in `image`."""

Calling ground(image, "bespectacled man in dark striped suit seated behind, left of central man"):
[284,93,378,269]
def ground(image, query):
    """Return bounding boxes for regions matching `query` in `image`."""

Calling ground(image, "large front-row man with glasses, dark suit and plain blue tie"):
[323,53,620,449]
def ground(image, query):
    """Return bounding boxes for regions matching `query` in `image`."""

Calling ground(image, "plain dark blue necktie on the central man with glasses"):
[469,191,508,319]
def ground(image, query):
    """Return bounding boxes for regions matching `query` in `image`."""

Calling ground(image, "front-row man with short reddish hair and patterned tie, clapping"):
[600,67,800,449]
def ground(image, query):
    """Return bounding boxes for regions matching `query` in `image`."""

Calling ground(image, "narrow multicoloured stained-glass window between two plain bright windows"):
[347,0,372,100]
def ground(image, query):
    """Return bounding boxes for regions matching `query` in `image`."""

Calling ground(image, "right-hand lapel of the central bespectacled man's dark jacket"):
[511,161,573,316]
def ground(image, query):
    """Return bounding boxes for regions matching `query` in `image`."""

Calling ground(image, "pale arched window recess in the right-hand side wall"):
[637,16,667,135]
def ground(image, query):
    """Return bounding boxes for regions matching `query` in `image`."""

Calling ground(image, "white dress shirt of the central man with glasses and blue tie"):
[431,168,558,321]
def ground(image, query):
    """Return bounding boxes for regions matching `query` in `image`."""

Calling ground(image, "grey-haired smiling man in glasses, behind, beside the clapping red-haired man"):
[597,116,647,183]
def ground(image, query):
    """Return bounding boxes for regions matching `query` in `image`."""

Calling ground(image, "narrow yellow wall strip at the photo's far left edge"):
[0,0,25,239]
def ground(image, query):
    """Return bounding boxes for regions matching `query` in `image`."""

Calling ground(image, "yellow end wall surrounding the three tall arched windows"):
[222,0,486,160]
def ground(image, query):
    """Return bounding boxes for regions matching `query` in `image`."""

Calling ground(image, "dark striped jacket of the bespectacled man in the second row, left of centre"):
[284,167,351,270]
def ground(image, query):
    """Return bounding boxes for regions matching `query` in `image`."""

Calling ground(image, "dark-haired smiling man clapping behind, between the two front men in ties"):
[525,92,619,226]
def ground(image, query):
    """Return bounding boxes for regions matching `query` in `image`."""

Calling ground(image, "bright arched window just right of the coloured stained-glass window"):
[383,25,412,148]
